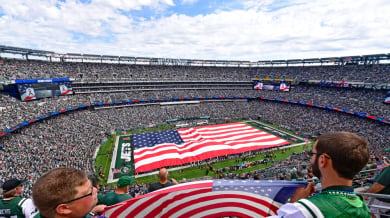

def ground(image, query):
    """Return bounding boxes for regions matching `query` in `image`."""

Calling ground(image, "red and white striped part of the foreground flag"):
[104,181,296,218]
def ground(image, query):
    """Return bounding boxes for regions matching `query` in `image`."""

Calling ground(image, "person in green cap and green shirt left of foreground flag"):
[103,176,134,206]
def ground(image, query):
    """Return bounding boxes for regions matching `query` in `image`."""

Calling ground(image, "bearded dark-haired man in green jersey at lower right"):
[270,132,371,218]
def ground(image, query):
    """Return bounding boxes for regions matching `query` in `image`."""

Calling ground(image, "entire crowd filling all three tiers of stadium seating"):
[0,59,390,201]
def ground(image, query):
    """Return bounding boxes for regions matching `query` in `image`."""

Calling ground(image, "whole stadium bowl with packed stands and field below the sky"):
[0,43,390,216]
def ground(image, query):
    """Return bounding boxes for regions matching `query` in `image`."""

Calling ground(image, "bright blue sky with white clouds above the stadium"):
[0,0,390,61]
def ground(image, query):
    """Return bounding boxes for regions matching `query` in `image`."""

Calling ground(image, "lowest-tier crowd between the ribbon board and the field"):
[0,101,390,198]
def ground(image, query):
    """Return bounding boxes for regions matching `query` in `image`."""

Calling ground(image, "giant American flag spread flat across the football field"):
[133,123,289,172]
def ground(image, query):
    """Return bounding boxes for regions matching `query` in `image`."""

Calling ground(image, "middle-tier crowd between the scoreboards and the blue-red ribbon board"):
[0,85,390,130]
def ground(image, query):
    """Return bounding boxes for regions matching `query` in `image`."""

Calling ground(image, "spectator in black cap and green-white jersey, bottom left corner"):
[0,179,36,218]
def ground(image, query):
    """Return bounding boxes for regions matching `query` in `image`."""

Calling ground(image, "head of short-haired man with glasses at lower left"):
[32,168,102,218]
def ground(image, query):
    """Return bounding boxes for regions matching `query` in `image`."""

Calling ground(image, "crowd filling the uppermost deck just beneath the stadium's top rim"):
[0,59,390,83]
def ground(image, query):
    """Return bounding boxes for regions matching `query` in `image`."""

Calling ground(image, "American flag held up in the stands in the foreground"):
[104,180,307,218]
